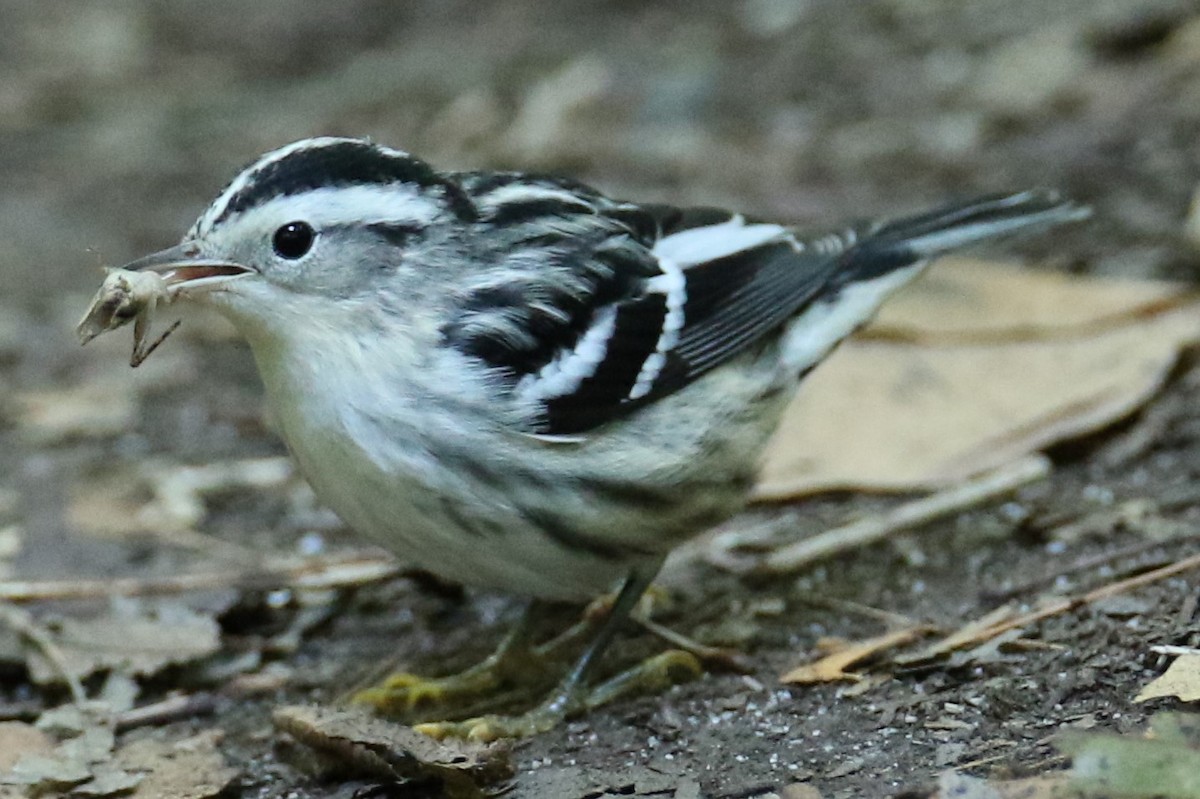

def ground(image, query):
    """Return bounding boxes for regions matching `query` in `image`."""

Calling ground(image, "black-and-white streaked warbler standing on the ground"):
[108,137,1088,739]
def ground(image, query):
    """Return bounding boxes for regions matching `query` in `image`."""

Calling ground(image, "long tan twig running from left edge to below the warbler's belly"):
[0,553,403,602]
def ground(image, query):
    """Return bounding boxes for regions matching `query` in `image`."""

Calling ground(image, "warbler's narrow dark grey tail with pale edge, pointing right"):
[851,188,1092,271]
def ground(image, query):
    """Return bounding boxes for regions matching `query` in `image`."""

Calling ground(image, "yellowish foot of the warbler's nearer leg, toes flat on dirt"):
[413,649,703,741]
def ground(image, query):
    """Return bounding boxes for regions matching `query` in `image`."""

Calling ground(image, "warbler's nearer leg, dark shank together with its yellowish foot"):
[415,573,703,740]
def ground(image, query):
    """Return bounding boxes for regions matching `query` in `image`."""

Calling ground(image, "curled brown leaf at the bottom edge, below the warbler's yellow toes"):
[272,705,512,799]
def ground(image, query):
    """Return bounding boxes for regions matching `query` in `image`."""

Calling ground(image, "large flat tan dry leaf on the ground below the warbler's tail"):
[757,259,1200,499]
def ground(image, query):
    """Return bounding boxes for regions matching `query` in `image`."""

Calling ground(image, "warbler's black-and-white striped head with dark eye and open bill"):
[126,138,474,329]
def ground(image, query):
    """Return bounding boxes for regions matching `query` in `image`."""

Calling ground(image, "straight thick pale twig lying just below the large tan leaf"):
[763,455,1050,573]
